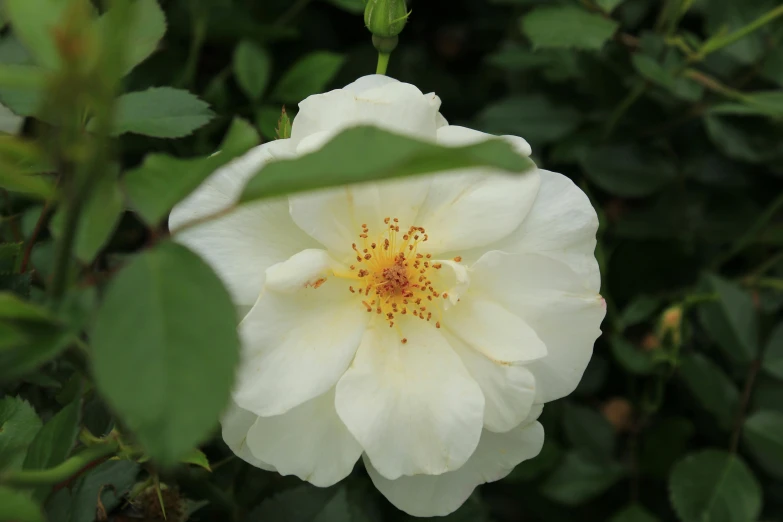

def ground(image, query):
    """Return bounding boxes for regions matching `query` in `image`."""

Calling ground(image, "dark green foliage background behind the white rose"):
[0,0,783,522]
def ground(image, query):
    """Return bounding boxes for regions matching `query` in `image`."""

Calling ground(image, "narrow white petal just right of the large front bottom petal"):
[446,335,536,432]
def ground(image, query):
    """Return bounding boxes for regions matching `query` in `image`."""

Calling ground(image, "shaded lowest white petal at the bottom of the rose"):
[364,416,544,517]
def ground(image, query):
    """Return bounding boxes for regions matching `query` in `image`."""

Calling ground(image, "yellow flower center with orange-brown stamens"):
[348,218,456,334]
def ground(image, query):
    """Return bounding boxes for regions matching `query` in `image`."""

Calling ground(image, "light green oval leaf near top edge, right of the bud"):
[522,6,619,50]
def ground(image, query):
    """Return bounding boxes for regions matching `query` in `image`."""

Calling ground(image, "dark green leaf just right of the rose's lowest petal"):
[541,451,625,506]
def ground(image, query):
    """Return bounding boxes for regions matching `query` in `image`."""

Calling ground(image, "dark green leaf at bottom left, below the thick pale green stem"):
[69,460,139,522]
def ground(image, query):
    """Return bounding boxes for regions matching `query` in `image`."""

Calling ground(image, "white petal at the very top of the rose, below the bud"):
[291,79,438,146]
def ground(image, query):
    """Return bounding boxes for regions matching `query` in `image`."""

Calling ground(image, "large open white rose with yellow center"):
[170,76,605,516]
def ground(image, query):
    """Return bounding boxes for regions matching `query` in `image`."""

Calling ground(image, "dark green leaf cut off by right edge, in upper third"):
[704,112,783,163]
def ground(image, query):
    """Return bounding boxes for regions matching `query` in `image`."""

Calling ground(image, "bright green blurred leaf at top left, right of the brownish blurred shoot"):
[97,0,166,74]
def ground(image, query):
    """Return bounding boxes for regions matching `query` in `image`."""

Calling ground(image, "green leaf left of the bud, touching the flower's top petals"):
[272,51,345,103]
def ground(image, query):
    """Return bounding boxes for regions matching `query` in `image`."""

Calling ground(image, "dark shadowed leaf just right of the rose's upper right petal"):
[582,144,677,198]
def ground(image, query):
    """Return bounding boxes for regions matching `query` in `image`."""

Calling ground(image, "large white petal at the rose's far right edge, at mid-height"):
[472,251,606,402]
